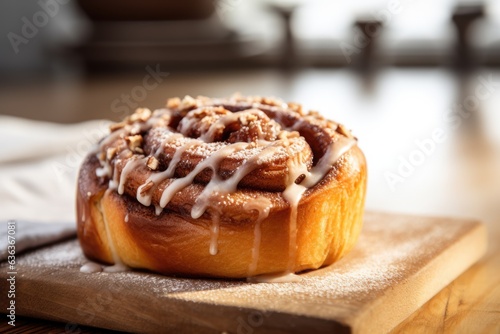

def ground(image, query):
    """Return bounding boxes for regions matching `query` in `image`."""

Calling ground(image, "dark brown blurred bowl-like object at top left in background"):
[73,0,266,72]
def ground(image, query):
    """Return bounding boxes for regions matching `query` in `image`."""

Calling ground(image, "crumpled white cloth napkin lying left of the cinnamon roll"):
[0,116,109,259]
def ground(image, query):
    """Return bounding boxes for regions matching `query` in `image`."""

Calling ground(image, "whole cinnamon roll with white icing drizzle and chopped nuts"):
[77,95,367,278]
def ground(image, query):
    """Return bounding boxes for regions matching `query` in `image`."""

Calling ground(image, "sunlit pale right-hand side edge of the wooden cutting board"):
[347,221,488,333]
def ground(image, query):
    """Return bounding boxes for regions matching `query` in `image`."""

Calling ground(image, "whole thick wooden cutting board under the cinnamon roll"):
[0,213,487,333]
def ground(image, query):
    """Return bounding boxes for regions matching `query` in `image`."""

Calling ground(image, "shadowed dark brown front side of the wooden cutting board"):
[8,280,351,334]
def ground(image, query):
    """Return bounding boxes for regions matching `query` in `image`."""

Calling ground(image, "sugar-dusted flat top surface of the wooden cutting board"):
[0,213,477,320]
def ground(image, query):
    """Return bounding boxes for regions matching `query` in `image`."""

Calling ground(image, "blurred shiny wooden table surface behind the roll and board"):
[0,68,500,333]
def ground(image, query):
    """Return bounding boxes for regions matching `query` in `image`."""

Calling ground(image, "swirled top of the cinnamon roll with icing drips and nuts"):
[78,96,365,277]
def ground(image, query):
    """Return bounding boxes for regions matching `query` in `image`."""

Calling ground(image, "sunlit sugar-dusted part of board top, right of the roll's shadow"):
[166,216,474,314]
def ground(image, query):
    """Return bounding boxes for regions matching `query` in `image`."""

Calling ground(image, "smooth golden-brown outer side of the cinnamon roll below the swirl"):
[77,95,367,278]
